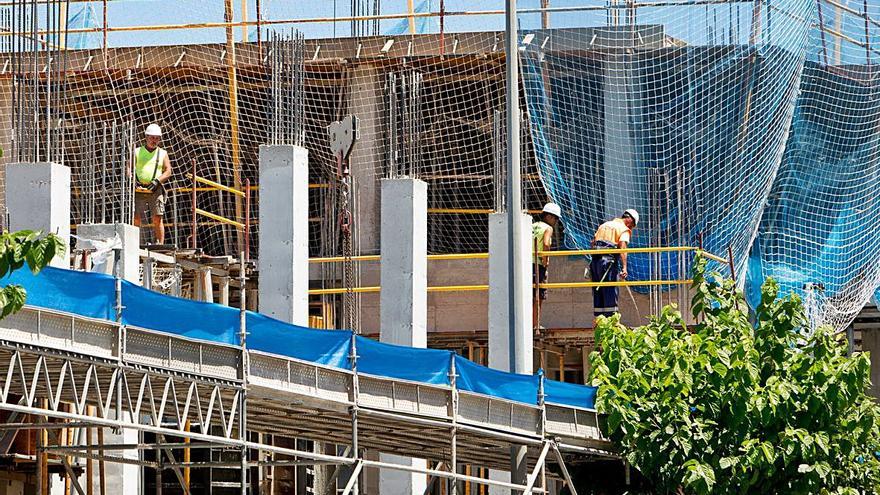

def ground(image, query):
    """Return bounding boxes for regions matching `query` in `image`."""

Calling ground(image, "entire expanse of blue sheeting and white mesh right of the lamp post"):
[521,0,880,329]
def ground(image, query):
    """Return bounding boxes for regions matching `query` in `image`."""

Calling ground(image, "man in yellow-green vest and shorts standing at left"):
[133,124,171,244]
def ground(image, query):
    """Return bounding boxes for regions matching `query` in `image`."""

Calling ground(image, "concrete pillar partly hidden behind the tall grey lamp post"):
[489,213,534,495]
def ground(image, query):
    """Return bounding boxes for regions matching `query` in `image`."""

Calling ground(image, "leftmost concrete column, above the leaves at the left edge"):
[6,162,70,268]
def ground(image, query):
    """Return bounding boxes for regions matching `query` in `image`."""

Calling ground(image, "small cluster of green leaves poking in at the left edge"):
[0,230,66,318]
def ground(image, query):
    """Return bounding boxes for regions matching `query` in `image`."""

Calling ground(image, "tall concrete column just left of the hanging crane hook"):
[259,145,309,326]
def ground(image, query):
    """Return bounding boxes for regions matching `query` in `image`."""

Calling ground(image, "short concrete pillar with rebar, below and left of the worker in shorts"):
[76,223,140,284]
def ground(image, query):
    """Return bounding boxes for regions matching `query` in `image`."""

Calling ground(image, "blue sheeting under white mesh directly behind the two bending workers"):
[522,33,816,292]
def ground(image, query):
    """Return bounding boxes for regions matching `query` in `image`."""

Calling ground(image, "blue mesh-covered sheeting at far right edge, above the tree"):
[747,62,880,326]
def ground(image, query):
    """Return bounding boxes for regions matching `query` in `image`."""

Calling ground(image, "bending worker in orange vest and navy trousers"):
[589,209,639,317]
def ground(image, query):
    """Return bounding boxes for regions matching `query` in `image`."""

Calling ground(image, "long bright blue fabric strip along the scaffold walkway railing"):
[0,268,596,409]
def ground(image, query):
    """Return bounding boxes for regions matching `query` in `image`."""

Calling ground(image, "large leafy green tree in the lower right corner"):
[591,258,880,494]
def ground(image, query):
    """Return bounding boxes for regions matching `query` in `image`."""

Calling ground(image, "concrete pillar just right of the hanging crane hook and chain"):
[379,179,428,495]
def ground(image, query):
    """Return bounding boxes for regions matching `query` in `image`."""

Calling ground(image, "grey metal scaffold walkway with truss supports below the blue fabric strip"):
[0,307,613,493]
